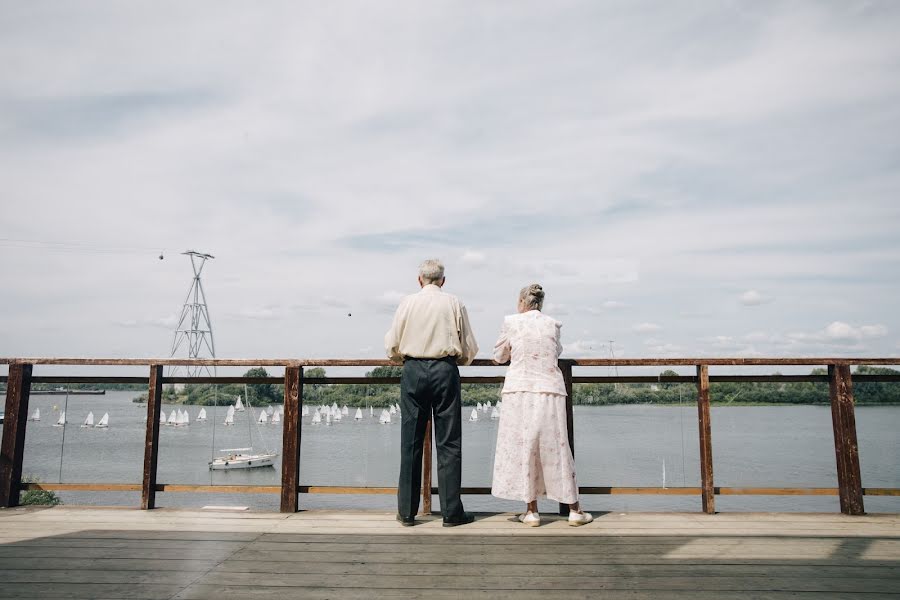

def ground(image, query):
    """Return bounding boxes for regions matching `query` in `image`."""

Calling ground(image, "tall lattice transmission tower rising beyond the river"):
[169,250,216,377]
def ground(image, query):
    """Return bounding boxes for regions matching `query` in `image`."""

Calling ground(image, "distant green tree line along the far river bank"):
[119,366,900,408]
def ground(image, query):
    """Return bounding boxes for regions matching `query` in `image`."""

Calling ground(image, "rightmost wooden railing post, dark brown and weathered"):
[828,364,866,515]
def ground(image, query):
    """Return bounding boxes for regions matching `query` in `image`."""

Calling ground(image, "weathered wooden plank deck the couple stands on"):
[0,507,900,600]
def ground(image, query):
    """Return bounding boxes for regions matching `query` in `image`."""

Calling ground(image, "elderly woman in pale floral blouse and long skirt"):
[491,283,593,527]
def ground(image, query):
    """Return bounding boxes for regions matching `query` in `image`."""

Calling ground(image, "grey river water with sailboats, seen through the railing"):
[8,392,900,512]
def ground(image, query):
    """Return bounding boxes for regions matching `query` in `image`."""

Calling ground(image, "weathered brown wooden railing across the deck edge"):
[0,358,900,515]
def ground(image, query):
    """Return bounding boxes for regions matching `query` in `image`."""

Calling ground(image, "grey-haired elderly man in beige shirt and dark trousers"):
[384,260,478,527]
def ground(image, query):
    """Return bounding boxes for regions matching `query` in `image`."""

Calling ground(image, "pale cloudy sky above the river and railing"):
[0,0,900,371]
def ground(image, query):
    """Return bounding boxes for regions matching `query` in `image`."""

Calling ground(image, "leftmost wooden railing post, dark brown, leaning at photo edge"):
[0,363,32,508]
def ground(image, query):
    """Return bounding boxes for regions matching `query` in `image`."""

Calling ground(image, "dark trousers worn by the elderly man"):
[397,357,463,519]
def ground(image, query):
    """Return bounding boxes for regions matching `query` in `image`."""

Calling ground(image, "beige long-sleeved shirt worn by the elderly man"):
[384,284,478,365]
